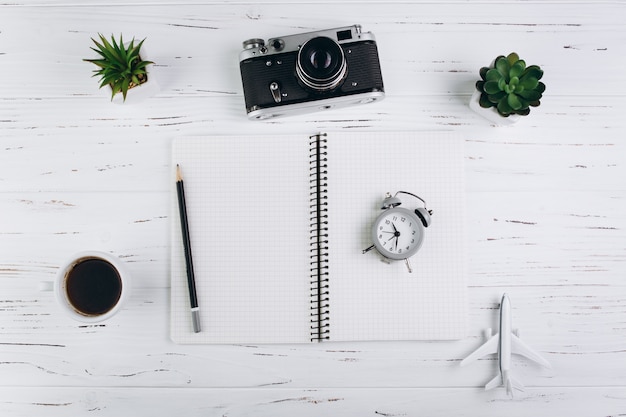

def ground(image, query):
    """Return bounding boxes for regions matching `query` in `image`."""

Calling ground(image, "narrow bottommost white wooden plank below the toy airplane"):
[0,387,626,417]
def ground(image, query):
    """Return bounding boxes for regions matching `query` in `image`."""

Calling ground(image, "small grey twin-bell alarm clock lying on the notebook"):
[363,191,432,272]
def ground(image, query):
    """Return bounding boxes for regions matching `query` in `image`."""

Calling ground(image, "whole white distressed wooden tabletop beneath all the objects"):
[0,0,626,417]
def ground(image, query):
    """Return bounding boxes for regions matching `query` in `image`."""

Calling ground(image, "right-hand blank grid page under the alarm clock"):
[328,132,467,340]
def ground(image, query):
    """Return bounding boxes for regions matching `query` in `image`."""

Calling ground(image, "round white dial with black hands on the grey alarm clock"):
[372,207,424,260]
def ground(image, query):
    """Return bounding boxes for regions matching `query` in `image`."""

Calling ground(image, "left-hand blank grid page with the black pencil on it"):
[171,136,310,343]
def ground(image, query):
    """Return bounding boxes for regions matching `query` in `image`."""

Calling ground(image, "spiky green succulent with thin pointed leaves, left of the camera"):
[83,34,154,101]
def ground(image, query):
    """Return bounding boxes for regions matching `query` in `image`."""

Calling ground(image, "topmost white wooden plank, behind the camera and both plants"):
[0,2,626,98]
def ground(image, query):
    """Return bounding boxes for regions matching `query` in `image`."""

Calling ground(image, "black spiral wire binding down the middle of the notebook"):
[309,134,330,342]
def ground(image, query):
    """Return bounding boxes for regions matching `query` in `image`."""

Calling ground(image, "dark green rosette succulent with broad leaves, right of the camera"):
[476,52,546,117]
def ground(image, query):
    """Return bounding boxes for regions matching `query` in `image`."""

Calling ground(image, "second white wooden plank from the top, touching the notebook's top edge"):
[0,96,626,192]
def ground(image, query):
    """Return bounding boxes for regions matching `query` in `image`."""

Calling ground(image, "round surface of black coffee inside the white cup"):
[65,258,122,316]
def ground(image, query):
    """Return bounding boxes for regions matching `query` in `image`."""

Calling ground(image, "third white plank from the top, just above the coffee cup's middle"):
[0,190,626,287]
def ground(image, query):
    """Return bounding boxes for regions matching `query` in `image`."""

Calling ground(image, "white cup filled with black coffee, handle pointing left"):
[40,251,130,323]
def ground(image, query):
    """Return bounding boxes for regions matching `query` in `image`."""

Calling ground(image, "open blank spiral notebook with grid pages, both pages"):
[171,132,467,343]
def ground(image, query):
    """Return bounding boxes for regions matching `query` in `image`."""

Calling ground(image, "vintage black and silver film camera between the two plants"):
[239,25,385,120]
